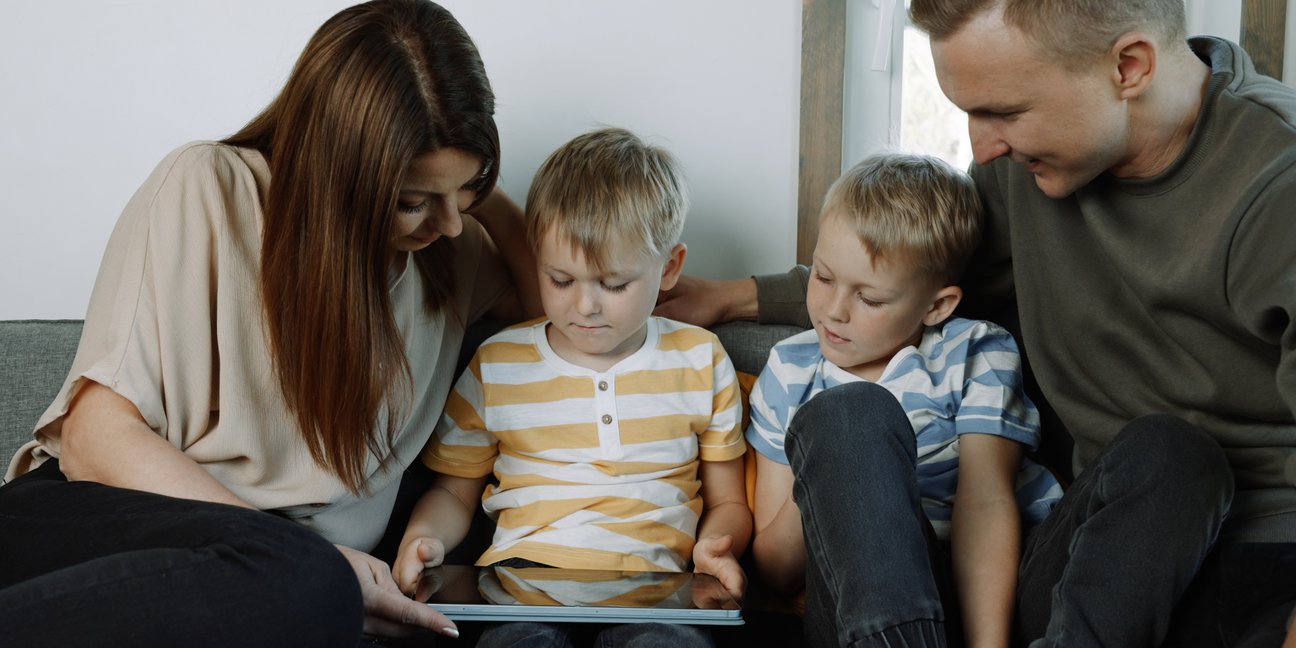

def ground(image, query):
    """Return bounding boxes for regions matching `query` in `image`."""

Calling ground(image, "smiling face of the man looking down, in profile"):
[932,10,1129,198]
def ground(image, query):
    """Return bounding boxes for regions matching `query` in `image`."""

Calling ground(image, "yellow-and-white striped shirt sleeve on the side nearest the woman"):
[420,353,499,478]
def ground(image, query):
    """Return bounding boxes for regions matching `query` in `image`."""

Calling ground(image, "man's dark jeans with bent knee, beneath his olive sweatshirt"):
[1017,415,1296,648]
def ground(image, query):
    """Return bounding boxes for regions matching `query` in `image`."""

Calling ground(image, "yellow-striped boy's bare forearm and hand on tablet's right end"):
[693,456,752,600]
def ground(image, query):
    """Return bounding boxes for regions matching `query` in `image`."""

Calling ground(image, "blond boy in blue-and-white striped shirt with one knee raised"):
[746,153,1061,645]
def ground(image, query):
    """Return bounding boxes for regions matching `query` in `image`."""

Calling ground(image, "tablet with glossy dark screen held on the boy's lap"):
[416,565,743,626]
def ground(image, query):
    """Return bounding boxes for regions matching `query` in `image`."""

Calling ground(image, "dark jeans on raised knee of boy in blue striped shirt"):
[787,382,958,647]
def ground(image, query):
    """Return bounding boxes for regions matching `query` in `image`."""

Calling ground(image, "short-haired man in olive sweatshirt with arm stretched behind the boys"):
[660,0,1296,647]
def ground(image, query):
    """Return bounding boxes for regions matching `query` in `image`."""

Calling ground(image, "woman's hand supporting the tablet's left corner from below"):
[334,544,459,639]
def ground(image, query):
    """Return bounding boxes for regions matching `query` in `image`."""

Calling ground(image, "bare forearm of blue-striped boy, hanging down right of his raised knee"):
[951,434,1021,648]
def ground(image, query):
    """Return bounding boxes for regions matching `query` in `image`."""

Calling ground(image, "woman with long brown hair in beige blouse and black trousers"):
[0,0,539,645]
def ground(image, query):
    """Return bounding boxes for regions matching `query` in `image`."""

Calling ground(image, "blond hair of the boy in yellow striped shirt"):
[526,128,688,271]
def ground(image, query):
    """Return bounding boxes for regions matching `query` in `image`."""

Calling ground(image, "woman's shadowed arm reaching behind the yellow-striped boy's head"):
[470,187,544,321]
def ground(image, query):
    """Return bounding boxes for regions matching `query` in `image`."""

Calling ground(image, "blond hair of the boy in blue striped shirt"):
[820,153,981,285]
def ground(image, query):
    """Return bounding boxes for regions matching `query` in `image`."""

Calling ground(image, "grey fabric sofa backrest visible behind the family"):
[0,320,800,487]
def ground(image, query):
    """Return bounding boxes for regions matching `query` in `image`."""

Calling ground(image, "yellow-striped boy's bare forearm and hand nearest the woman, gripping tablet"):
[393,473,486,595]
